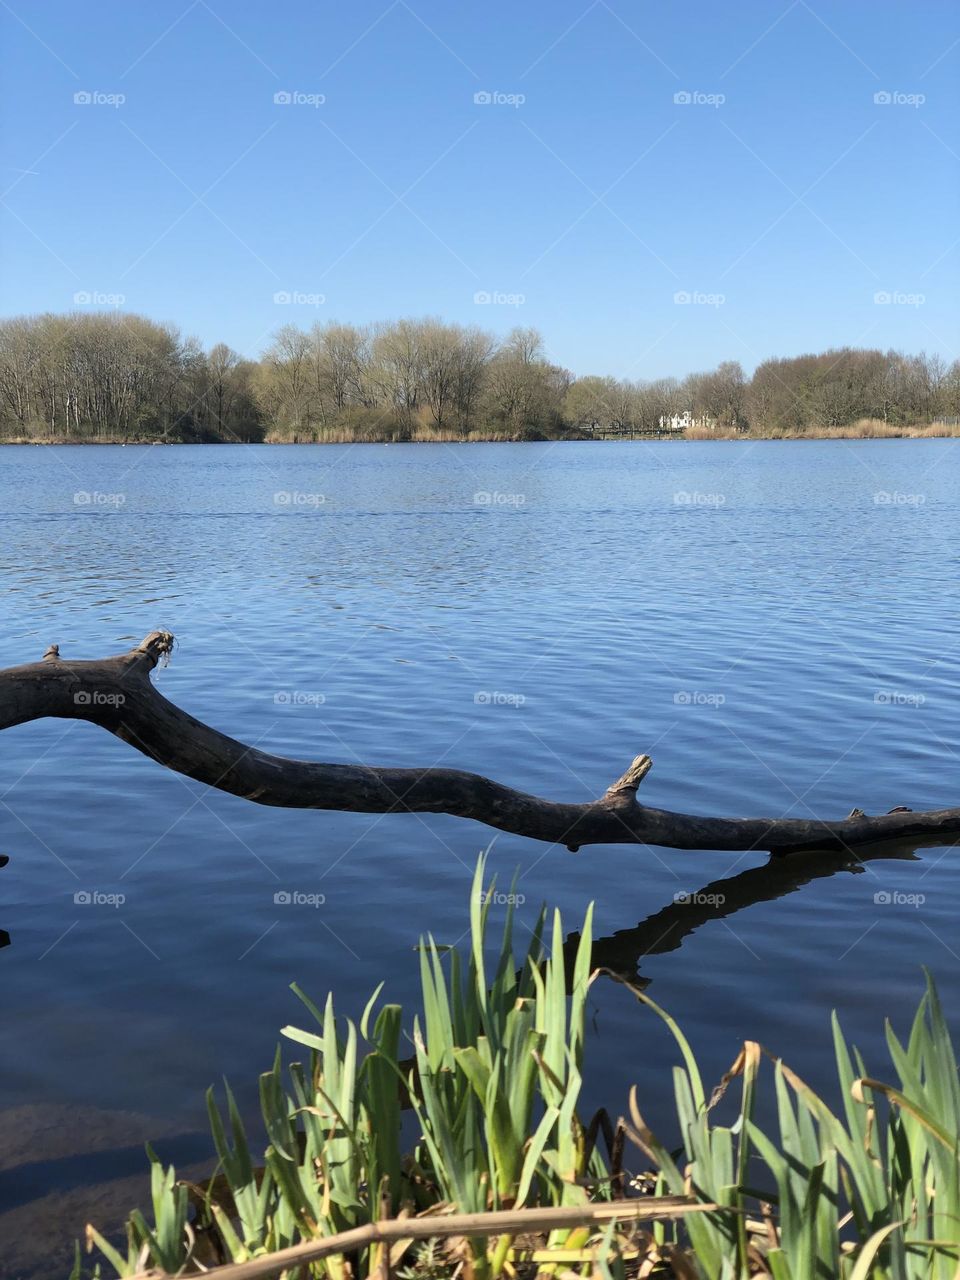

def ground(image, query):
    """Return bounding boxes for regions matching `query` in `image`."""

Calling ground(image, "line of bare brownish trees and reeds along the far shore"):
[0,312,960,443]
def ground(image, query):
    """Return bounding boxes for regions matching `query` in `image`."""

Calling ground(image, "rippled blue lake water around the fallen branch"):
[0,440,960,1275]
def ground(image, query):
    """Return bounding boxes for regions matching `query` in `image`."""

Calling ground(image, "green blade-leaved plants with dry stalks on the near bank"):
[73,858,960,1280]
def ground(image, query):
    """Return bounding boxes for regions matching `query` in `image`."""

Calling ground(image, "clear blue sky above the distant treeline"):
[0,0,960,378]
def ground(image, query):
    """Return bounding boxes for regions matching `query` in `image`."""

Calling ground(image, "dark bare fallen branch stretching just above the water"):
[0,631,960,854]
